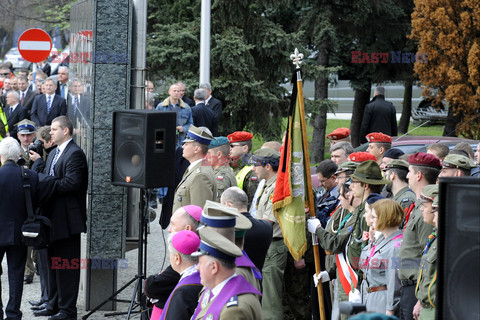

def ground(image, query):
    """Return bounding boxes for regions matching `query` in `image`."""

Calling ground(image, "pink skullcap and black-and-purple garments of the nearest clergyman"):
[158,230,203,320]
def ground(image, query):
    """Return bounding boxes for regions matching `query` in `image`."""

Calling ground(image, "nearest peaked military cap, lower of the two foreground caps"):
[191,228,243,262]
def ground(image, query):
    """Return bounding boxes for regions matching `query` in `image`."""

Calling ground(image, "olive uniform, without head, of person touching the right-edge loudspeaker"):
[415,234,438,320]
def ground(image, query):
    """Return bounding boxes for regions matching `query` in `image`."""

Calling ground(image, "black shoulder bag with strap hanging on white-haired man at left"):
[20,166,53,249]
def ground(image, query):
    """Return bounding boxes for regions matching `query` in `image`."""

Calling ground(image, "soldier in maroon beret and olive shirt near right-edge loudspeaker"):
[398,152,441,320]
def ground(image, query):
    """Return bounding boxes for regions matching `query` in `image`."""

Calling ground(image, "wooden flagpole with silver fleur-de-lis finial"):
[290,48,325,320]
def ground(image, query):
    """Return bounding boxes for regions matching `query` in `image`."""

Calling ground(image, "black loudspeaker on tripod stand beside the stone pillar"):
[111,110,177,189]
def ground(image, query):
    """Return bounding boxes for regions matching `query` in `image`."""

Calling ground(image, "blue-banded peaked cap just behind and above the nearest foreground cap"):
[200,200,252,231]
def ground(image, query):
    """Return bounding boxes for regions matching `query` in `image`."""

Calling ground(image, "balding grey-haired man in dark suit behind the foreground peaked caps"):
[220,187,273,270]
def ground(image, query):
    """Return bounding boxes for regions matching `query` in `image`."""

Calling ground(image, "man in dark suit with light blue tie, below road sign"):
[30,78,67,127]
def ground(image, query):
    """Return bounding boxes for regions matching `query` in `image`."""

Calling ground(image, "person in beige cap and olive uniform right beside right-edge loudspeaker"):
[413,184,438,320]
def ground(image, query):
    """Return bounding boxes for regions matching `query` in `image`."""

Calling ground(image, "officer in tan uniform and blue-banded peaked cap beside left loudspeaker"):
[172,125,217,212]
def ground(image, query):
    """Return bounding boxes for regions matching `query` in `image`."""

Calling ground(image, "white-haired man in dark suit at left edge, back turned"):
[0,137,38,319]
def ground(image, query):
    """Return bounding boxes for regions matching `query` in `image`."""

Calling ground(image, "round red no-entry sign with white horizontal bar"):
[18,29,52,62]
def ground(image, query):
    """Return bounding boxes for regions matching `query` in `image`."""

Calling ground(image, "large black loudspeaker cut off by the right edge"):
[436,177,480,320]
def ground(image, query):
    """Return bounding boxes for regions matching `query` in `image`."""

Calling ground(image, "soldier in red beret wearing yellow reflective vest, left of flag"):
[227,131,259,208]
